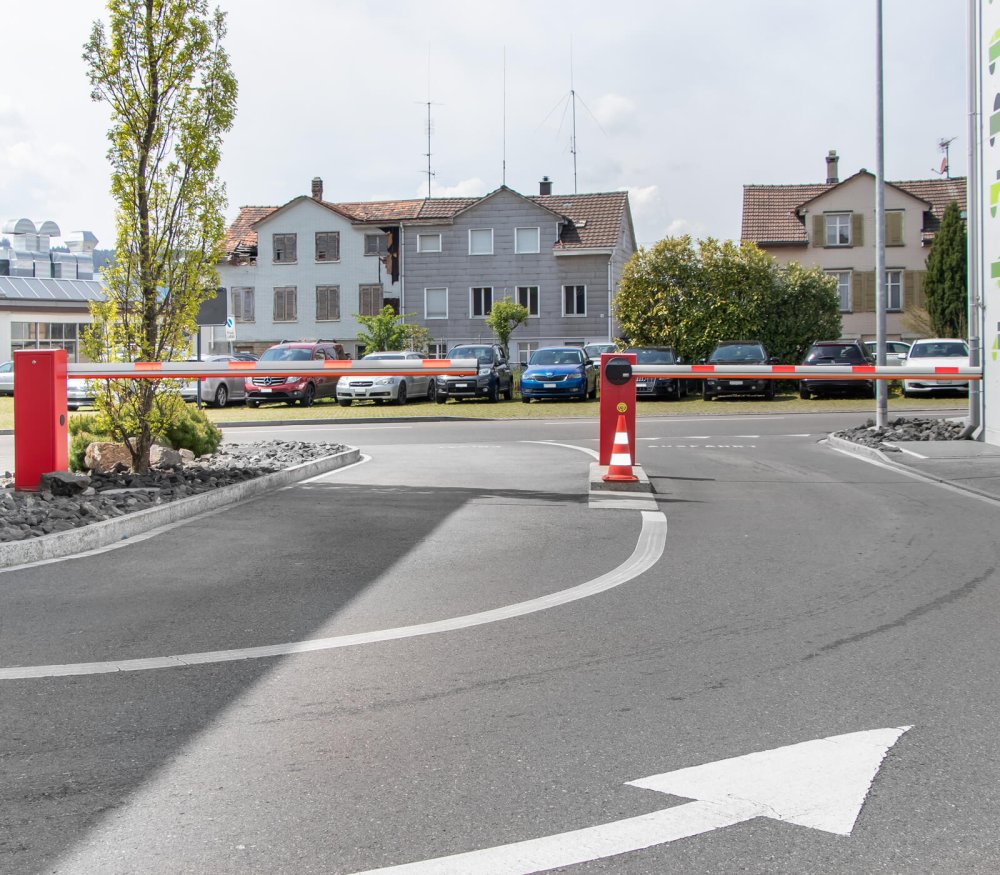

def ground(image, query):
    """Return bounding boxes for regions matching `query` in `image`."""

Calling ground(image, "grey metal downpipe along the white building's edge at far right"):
[965,0,983,435]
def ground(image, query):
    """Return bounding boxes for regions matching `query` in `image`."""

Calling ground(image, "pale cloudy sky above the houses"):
[0,0,969,248]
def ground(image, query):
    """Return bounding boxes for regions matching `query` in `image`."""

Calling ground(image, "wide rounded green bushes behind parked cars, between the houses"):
[614,236,841,362]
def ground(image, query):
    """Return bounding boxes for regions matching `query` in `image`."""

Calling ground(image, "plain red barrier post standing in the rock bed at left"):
[14,349,69,491]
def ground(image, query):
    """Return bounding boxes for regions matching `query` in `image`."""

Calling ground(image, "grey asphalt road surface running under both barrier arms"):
[0,415,1000,875]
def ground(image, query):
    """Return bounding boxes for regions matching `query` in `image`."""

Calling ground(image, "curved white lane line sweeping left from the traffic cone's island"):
[0,510,667,680]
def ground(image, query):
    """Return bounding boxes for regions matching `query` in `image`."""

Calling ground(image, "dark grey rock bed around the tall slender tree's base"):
[0,441,345,542]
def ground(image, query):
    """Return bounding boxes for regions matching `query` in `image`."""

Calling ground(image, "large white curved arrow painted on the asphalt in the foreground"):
[357,726,910,875]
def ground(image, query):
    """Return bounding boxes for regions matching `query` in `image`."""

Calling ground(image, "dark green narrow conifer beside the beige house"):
[924,201,969,337]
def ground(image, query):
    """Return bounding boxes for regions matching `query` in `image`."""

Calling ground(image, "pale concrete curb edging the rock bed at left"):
[0,448,361,568]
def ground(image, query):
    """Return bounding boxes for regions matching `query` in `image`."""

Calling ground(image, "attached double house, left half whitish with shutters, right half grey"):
[220,179,636,360]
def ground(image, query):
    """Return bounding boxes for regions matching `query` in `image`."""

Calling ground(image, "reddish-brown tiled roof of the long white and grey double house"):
[226,191,628,255]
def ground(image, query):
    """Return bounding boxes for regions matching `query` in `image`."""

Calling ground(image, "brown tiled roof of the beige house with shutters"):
[740,178,965,245]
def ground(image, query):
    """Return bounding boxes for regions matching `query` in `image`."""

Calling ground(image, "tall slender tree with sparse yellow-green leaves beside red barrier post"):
[83,0,237,471]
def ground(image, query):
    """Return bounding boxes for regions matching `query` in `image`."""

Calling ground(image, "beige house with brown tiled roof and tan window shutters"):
[740,151,966,340]
